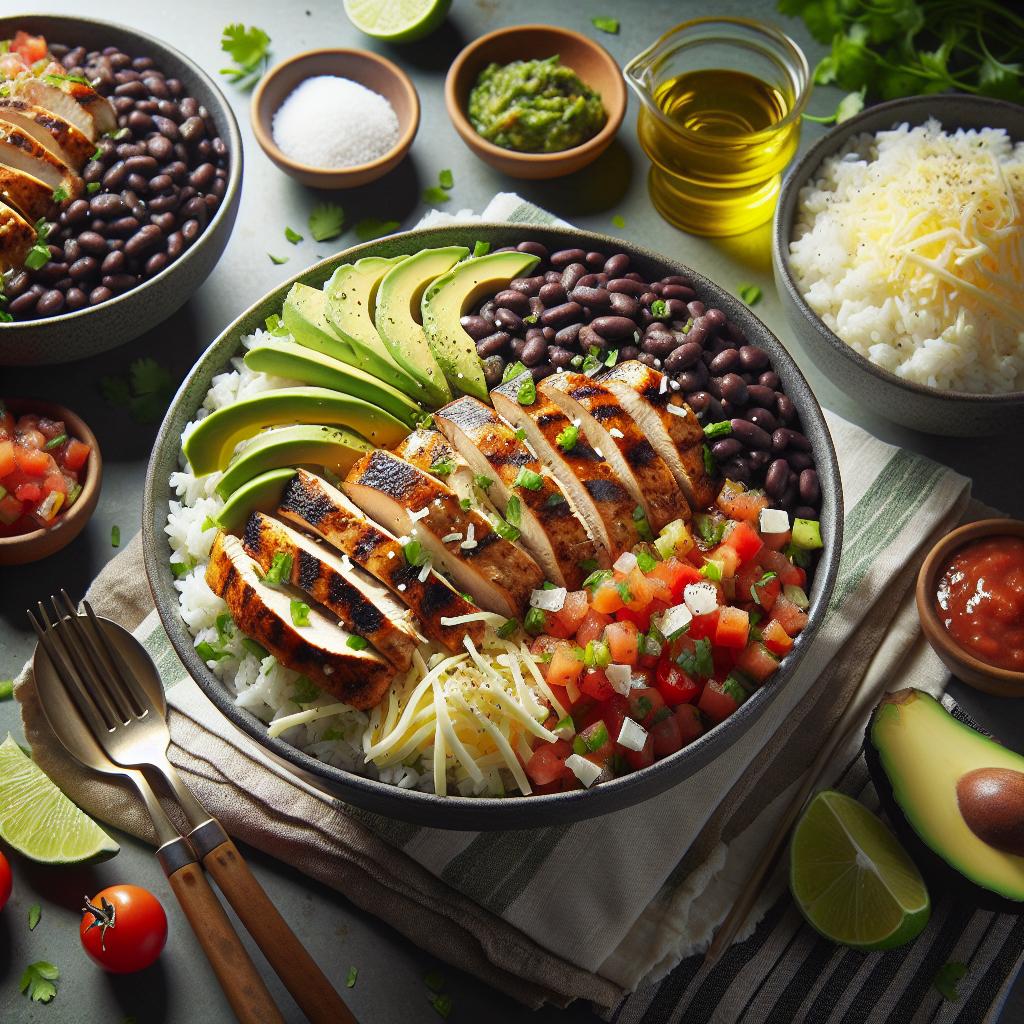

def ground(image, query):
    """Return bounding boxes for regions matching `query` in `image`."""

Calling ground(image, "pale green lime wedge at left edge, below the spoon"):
[0,735,121,864]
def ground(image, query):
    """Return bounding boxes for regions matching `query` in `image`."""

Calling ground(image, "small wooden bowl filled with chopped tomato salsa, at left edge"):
[0,398,102,565]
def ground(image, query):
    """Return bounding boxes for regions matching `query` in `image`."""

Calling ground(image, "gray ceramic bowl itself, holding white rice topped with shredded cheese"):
[772,93,1024,408]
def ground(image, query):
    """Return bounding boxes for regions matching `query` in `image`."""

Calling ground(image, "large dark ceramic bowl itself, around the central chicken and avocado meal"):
[148,223,843,829]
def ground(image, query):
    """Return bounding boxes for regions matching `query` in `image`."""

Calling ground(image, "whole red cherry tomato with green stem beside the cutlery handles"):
[79,885,167,974]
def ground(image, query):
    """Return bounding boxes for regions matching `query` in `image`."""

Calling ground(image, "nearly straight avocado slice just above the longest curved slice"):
[245,341,423,427]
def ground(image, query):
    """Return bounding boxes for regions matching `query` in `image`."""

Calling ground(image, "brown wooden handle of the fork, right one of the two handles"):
[203,839,357,1024]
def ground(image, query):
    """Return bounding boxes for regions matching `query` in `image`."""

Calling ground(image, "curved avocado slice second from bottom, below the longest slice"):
[217,423,374,499]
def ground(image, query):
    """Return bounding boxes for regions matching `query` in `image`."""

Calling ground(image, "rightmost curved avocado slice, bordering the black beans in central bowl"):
[421,252,538,401]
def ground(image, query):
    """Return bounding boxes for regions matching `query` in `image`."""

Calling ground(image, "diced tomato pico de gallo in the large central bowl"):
[523,481,822,793]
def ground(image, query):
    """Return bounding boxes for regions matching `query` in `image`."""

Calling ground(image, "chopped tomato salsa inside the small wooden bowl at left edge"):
[0,403,91,537]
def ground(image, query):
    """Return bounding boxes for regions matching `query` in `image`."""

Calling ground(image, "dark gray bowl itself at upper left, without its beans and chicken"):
[0,14,242,367]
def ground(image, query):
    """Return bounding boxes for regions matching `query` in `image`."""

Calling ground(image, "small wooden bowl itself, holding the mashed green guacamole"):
[444,25,626,178]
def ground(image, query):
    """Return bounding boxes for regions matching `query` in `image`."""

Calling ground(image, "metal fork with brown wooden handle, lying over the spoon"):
[30,591,356,1024]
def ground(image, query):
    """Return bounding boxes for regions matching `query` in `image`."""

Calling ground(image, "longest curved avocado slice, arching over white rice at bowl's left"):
[181,387,409,476]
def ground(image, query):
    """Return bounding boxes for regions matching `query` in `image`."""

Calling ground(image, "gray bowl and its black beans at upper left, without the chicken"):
[0,14,242,366]
